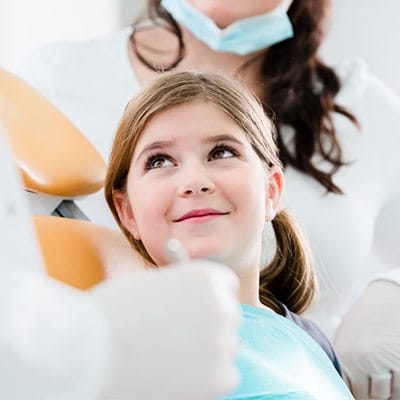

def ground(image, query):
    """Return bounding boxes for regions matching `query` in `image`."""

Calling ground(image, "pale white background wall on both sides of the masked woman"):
[0,0,400,94]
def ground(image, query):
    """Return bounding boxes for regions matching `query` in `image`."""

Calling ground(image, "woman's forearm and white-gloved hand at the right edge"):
[334,198,400,399]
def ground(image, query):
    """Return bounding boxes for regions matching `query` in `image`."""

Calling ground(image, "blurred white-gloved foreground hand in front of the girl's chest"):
[91,261,240,400]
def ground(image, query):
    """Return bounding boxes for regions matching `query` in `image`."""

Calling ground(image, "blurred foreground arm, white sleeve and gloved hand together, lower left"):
[0,262,240,400]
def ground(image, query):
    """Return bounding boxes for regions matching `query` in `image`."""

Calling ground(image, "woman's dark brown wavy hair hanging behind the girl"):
[131,0,358,193]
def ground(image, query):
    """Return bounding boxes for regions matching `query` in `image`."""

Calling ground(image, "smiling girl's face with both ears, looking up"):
[114,101,283,269]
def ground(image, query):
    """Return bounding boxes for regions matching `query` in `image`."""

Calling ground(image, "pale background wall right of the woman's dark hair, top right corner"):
[322,0,400,95]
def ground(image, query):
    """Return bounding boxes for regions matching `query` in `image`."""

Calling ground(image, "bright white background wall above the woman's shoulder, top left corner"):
[0,0,120,69]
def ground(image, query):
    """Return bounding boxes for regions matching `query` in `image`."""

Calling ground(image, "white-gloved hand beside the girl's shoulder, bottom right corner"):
[334,281,400,400]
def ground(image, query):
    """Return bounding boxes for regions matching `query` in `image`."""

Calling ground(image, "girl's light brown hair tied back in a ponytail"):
[105,72,315,312]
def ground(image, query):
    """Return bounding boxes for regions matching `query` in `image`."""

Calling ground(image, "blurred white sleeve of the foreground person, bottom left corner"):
[0,268,108,400]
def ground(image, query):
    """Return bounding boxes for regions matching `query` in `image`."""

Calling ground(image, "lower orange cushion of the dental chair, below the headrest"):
[33,215,139,289]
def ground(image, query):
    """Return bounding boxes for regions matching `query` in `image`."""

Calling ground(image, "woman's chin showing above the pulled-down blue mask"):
[188,0,283,28]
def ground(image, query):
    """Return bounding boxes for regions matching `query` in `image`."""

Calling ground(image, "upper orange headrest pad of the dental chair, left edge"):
[0,69,106,198]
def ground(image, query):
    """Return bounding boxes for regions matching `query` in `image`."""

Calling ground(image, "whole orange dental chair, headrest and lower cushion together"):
[0,70,144,289]
